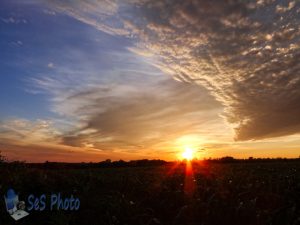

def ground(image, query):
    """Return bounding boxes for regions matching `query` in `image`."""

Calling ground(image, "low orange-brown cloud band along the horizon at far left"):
[0,118,170,162]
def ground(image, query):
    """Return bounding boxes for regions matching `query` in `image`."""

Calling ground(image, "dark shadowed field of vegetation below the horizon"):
[0,157,300,225]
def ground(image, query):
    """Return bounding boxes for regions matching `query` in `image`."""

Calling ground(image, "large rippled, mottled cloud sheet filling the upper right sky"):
[47,0,300,140]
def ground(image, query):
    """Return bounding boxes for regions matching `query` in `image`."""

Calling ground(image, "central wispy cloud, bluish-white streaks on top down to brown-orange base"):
[32,57,224,152]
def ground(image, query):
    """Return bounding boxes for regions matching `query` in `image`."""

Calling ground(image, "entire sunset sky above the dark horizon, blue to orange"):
[0,0,300,162]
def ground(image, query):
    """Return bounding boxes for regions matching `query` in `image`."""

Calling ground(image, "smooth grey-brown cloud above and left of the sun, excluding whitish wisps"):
[62,76,221,150]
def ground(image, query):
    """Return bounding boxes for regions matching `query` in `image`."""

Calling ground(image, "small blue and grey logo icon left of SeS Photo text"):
[4,189,29,221]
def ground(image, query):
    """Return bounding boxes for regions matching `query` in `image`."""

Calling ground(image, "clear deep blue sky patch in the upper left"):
[0,1,130,119]
